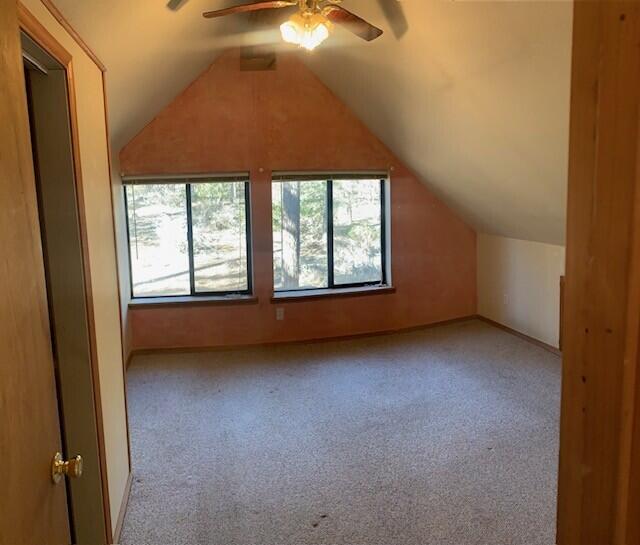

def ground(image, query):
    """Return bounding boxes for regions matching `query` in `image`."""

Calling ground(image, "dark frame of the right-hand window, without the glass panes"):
[271,173,389,297]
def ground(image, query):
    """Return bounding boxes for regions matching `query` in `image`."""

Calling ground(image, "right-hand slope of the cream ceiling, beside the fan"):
[308,0,573,244]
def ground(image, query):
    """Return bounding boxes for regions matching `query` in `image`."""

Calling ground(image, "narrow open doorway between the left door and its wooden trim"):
[21,33,108,543]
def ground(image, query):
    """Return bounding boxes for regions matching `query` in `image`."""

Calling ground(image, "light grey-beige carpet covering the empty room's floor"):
[122,321,560,545]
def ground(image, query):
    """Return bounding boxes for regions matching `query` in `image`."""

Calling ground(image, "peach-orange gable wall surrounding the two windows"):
[120,50,476,350]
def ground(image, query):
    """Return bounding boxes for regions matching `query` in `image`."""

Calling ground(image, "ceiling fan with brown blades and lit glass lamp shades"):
[167,0,408,51]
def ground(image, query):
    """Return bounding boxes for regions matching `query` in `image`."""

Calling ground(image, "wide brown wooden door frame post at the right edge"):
[557,0,640,545]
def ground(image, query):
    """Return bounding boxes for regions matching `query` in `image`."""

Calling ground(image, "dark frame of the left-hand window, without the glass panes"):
[122,175,253,302]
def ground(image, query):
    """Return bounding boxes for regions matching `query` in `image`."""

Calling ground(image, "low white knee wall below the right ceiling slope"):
[478,234,565,348]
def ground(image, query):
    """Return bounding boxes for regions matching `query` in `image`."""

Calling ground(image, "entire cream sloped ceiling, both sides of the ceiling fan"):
[56,0,572,244]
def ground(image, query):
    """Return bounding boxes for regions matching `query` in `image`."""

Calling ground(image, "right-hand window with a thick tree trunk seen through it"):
[272,175,387,291]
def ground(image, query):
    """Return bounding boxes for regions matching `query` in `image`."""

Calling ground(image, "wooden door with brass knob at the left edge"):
[0,0,70,544]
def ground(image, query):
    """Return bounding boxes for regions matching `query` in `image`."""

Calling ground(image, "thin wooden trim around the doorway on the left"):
[17,2,120,543]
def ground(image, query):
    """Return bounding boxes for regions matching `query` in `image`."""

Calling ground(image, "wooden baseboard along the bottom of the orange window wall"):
[127,314,478,365]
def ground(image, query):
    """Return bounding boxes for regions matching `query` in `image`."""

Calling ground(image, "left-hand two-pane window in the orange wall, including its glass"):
[125,178,251,298]
